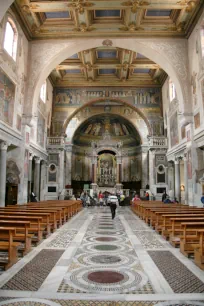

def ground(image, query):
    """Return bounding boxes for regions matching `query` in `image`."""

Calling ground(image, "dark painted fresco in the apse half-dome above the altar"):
[73,114,140,147]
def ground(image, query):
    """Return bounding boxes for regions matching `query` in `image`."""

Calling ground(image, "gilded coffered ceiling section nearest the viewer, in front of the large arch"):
[12,0,203,39]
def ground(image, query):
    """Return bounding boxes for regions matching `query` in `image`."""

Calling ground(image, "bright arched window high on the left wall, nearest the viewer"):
[4,18,18,60]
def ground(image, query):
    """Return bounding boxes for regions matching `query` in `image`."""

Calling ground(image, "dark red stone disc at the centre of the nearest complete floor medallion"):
[88,271,124,284]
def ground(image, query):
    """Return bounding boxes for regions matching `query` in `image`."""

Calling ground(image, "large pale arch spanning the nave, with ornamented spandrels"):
[25,38,190,120]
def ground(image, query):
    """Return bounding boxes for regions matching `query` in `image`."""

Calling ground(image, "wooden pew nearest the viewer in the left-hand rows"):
[0,227,21,270]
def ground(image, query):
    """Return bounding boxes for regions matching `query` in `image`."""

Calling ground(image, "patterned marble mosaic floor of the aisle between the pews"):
[0,207,204,306]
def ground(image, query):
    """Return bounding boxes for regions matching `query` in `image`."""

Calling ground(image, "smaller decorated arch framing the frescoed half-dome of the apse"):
[63,98,147,144]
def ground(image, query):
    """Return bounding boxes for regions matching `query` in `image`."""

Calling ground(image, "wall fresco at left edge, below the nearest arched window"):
[0,69,15,126]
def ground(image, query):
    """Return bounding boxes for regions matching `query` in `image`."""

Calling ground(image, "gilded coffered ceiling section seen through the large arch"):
[50,47,167,87]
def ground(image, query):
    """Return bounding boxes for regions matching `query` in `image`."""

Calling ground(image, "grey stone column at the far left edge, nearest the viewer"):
[0,141,8,207]
